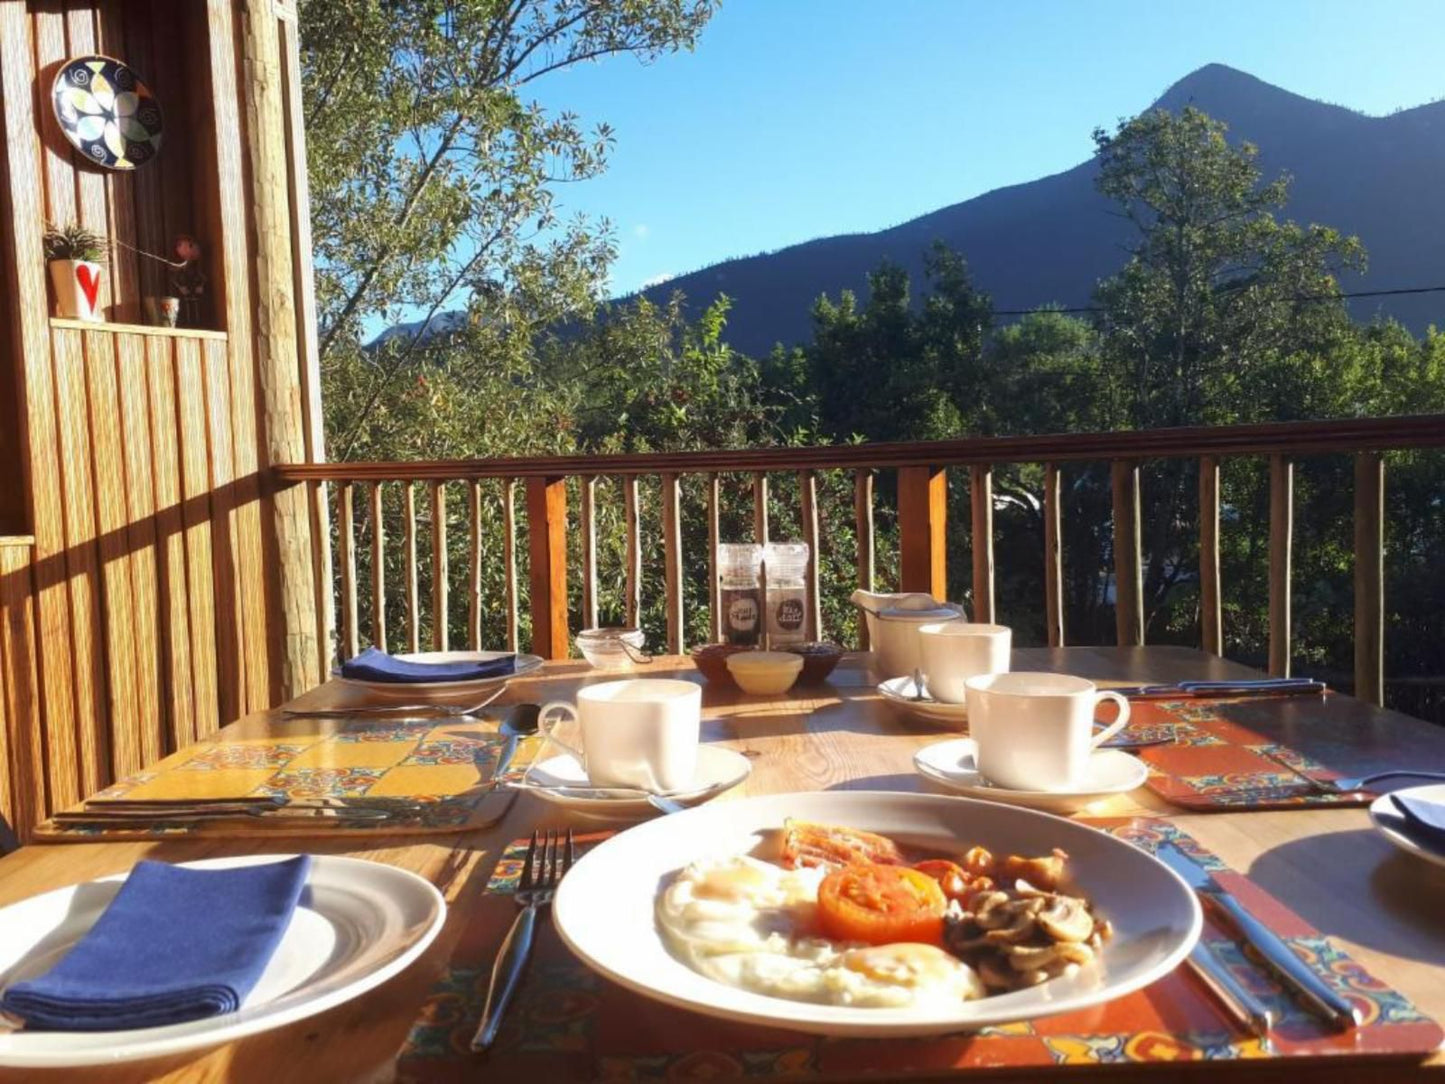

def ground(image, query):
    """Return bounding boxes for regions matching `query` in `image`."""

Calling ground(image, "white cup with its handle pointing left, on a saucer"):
[538,678,702,793]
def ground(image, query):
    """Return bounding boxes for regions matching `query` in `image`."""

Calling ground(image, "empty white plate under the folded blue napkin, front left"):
[0,854,447,1068]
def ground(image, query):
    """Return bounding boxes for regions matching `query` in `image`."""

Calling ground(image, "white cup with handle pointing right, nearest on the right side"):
[968,671,1129,791]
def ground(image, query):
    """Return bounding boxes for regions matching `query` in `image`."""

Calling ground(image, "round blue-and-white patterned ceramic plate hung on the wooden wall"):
[51,56,165,169]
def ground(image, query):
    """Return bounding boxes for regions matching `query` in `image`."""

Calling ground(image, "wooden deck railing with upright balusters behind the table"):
[275,415,1445,702]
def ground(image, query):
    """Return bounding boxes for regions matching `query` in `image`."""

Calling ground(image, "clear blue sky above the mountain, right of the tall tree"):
[535,0,1445,292]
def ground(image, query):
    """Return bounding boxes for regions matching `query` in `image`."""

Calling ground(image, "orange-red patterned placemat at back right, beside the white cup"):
[1123,697,1373,812]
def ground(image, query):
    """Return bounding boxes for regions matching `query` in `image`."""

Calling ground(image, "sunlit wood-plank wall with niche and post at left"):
[0,0,327,835]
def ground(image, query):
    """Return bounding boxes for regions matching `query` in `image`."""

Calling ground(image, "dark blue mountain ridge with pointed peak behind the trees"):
[642,64,1445,356]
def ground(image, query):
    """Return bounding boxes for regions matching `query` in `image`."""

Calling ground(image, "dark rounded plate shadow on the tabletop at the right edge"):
[1247,828,1445,965]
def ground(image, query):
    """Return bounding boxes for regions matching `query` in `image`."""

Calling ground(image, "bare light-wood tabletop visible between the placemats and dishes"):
[0,648,1445,1084]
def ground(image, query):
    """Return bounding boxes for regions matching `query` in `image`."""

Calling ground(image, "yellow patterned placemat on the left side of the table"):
[33,718,536,843]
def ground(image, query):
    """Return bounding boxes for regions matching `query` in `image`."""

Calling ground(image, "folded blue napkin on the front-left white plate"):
[0,854,311,1032]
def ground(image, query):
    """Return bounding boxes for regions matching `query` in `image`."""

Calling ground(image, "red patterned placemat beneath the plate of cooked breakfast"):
[397,818,1445,1083]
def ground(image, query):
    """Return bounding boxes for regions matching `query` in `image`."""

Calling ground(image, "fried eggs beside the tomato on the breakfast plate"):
[657,854,984,1007]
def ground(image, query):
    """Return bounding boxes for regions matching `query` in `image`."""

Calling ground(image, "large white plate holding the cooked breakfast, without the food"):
[552,791,1201,1038]
